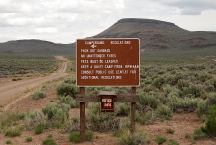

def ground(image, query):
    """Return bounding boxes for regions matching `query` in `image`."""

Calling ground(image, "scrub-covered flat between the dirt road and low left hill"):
[0,54,57,77]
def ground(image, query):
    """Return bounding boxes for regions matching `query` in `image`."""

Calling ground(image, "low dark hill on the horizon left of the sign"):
[0,39,74,55]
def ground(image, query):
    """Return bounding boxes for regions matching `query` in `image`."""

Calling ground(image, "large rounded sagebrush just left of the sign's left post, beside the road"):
[42,103,70,128]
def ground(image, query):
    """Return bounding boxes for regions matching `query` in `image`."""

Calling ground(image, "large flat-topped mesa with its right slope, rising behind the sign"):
[93,18,216,51]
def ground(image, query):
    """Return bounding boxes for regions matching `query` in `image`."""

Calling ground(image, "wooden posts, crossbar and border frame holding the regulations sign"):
[76,38,140,141]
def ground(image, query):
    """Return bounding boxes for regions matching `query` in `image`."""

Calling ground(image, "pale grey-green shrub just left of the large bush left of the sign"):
[25,111,47,130]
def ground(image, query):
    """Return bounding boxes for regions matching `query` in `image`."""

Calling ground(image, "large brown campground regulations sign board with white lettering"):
[76,38,140,86]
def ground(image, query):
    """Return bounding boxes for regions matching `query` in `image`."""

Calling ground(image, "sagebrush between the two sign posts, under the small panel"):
[88,103,120,131]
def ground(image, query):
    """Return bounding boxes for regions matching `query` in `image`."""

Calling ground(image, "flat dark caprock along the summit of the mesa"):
[116,18,176,26]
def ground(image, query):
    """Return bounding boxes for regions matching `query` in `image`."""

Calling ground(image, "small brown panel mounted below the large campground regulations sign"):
[101,96,114,112]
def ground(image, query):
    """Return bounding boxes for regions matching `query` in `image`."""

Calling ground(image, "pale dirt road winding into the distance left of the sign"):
[0,56,68,110]
